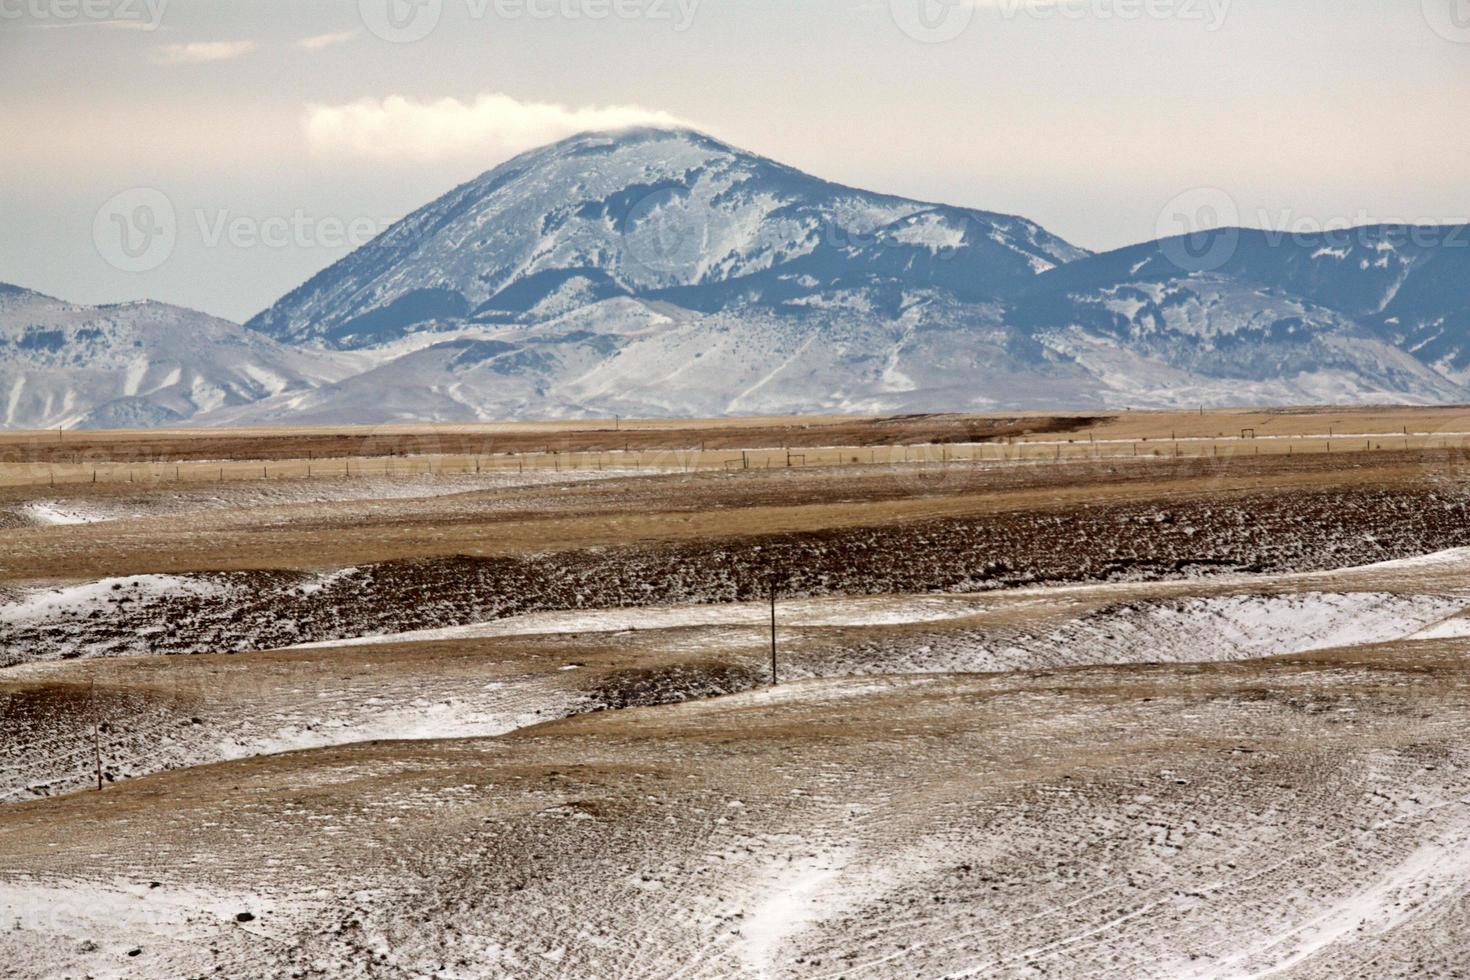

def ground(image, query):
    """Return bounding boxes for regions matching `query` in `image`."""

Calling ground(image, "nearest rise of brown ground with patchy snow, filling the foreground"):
[11,658,1470,980]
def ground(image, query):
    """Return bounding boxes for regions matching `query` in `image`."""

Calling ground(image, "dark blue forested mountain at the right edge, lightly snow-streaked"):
[1005,226,1470,404]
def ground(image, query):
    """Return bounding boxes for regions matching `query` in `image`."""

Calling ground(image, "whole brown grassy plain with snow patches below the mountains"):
[0,408,1470,980]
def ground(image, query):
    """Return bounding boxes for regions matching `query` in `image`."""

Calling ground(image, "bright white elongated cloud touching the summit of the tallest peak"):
[304,93,684,162]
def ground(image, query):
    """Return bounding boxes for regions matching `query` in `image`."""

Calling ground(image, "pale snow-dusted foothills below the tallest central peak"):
[201,297,1105,425]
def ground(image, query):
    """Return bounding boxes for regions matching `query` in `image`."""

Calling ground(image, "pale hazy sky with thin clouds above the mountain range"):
[0,0,1470,320]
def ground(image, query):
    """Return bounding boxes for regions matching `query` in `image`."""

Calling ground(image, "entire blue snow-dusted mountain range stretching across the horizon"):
[0,129,1470,426]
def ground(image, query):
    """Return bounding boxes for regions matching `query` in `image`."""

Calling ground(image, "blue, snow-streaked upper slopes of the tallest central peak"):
[247,129,1086,348]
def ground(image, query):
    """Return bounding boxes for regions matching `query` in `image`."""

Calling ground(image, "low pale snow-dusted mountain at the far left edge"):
[0,284,353,429]
